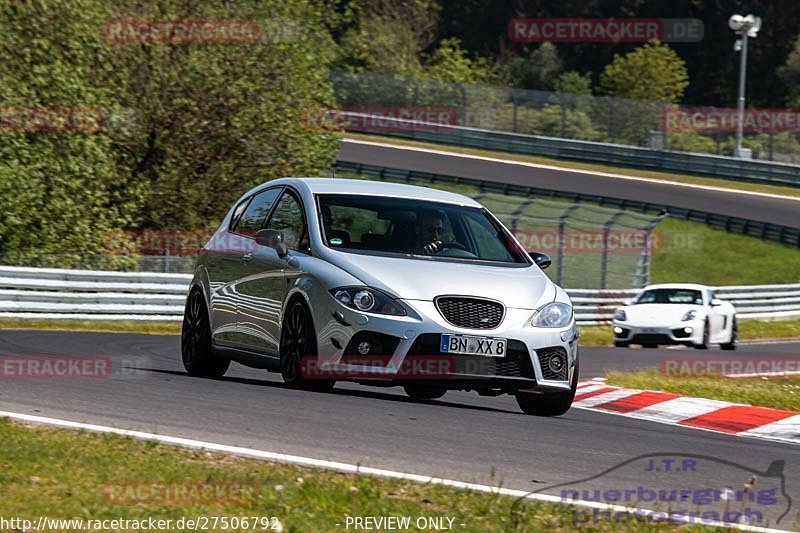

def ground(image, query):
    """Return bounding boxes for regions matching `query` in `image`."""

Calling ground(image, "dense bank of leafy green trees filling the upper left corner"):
[0,0,338,266]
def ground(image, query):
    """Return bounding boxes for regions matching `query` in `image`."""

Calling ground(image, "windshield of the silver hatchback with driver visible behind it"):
[318,194,529,264]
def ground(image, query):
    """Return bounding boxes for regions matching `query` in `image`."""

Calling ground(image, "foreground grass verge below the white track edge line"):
[0,419,728,532]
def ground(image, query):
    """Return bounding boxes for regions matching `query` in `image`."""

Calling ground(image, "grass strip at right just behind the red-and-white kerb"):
[606,370,800,411]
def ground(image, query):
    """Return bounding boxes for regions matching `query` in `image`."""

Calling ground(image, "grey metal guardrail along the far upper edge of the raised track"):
[341,111,800,187]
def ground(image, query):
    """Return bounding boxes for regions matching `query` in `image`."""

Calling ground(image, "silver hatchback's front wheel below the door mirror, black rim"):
[280,299,336,391]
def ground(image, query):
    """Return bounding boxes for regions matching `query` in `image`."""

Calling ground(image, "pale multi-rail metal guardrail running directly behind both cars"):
[0,267,800,325]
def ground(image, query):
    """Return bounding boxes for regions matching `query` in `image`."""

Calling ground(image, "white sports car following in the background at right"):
[612,283,738,350]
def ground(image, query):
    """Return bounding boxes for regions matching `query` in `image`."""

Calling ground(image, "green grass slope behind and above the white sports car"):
[650,217,800,285]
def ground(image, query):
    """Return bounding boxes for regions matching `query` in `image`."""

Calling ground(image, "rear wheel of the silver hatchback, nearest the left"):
[181,289,231,378]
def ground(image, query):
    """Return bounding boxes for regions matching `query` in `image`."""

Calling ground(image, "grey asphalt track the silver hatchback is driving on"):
[0,330,800,529]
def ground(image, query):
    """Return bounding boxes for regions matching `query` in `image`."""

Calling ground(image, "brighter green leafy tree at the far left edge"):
[0,2,144,267]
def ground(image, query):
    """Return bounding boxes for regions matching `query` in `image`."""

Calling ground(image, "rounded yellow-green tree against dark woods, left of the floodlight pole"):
[600,42,689,104]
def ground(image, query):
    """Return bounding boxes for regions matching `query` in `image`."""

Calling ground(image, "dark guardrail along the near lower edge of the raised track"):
[334,161,800,248]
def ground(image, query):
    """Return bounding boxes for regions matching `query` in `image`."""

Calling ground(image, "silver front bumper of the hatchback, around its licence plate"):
[315,300,578,392]
